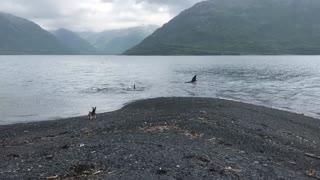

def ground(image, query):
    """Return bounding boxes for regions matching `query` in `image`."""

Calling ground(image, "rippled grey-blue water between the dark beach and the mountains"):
[0,56,320,124]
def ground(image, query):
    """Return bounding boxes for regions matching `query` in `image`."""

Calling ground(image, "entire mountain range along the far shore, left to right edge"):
[0,0,320,55]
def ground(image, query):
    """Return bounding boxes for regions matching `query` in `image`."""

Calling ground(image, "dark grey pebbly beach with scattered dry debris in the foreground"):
[0,98,320,179]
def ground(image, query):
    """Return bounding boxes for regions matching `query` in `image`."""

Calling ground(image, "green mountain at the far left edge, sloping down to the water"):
[0,12,74,55]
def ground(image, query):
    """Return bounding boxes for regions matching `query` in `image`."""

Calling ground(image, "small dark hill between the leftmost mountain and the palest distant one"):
[52,28,98,55]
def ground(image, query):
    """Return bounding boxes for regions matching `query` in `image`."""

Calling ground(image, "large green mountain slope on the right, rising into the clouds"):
[124,0,320,55]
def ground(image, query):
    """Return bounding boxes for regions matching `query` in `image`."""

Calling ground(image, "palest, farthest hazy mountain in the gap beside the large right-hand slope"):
[78,25,158,54]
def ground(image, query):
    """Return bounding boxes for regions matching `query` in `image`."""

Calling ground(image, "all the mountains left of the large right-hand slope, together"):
[0,13,157,55]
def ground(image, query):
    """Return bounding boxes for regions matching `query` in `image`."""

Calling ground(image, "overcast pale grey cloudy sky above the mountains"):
[0,0,201,31]
